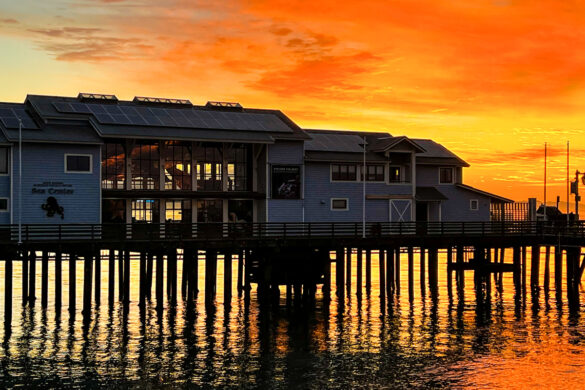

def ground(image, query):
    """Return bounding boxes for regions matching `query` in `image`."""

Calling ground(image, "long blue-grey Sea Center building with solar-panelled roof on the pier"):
[0,94,510,224]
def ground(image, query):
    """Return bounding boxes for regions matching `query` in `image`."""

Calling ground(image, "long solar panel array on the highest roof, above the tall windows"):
[53,102,292,133]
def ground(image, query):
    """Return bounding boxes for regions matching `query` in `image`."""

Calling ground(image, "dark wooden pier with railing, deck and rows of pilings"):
[0,222,585,328]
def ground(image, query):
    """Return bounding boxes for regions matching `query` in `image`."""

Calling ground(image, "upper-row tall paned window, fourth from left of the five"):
[195,144,223,191]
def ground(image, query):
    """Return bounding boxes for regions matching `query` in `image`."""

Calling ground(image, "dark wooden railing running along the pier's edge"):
[0,221,585,243]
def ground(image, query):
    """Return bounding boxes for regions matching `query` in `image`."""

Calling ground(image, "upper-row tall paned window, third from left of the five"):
[165,141,192,190]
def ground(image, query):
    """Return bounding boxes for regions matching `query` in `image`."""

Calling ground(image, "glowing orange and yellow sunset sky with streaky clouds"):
[0,0,585,209]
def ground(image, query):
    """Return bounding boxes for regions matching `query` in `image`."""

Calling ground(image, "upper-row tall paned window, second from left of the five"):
[130,143,160,190]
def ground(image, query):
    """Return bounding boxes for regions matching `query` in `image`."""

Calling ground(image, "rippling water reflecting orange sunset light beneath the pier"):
[0,251,585,389]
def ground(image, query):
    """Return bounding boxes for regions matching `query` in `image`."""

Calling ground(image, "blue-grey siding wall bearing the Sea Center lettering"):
[13,144,101,224]
